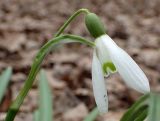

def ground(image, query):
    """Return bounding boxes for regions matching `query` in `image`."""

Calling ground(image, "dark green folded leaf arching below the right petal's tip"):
[120,94,149,121]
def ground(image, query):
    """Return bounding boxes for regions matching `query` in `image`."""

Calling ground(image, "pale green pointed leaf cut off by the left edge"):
[0,67,12,103]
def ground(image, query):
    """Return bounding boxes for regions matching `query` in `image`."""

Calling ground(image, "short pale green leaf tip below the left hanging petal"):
[84,107,99,121]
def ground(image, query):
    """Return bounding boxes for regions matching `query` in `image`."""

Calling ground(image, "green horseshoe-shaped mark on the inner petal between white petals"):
[103,62,116,75]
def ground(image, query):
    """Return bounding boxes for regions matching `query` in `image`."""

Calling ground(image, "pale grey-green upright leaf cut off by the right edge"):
[148,93,160,121]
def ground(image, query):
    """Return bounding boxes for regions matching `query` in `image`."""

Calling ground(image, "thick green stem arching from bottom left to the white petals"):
[5,34,95,121]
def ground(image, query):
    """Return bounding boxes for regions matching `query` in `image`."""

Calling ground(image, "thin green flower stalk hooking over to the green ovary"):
[55,8,90,37]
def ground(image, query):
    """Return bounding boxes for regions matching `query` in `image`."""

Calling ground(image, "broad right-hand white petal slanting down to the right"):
[105,42,150,93]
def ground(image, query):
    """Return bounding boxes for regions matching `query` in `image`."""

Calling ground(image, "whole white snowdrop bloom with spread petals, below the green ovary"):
[92,35,150,113]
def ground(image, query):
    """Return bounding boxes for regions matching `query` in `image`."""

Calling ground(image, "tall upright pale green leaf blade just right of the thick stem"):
[39,70,53,121]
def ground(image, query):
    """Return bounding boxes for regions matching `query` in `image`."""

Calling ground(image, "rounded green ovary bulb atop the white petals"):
[85,13,105,38]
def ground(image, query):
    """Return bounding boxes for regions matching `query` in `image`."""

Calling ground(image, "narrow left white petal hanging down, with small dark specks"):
[92,51,108,113]
